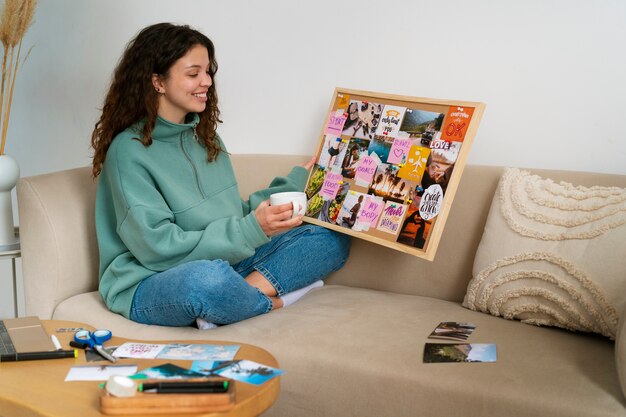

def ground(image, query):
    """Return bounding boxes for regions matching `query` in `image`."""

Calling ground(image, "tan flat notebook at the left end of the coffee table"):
[0,316,56,354]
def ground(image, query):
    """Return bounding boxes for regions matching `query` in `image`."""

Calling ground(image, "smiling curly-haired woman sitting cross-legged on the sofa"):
[92,23,349,326]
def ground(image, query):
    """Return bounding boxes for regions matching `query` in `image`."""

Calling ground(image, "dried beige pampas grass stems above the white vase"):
[0,0,37,155]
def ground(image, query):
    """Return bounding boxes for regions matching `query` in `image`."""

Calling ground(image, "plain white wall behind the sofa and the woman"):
[0,0,626,316]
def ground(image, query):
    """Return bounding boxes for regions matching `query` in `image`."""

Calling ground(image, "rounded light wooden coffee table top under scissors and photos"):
[0,320,280,417]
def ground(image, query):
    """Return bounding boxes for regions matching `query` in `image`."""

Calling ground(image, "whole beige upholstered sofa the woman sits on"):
[17,155,626,417]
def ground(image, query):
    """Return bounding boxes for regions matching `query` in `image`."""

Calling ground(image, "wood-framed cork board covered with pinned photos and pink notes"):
[305,88,485,261]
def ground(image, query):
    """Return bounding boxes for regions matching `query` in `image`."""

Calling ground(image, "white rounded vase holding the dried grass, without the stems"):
[0,155,20,246]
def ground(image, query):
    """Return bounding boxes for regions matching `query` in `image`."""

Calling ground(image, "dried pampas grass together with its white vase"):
[0,0,37,246]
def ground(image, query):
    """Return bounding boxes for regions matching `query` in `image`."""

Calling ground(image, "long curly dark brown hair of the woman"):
[91,23,222,178]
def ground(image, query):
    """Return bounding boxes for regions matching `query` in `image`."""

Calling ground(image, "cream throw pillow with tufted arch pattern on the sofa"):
[463,168,626,339]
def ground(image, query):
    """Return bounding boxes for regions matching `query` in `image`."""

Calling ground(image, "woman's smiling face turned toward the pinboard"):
[152,45,213,123]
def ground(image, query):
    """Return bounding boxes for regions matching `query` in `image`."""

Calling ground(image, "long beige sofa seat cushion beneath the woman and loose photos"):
[54,285,626,417]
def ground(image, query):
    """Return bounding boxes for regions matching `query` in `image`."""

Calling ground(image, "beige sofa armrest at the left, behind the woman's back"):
[17,167,98,319]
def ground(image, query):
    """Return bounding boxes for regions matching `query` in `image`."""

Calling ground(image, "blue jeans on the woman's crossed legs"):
[130,225,350,326]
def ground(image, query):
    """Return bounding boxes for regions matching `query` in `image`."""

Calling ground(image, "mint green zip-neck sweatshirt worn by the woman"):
[96,114,307,318]
